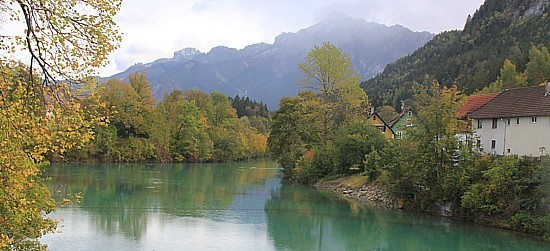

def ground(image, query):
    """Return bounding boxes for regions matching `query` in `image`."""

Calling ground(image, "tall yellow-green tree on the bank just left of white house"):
[382,79,465,210]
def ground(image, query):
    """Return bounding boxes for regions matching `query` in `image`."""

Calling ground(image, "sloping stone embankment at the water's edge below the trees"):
[315,178,402,209]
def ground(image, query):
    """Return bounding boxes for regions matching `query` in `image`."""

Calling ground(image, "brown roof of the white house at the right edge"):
[471,86,550,118]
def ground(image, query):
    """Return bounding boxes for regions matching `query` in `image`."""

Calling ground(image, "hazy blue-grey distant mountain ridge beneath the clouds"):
[111,15,433,110]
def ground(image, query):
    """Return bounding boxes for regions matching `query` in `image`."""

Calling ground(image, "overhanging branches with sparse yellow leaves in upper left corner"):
[0,0,122,84]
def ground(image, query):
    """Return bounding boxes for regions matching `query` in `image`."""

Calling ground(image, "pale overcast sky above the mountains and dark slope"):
[100,0,483,76]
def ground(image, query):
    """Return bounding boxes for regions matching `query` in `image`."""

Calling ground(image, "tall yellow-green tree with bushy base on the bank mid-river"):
[268,42,379,183]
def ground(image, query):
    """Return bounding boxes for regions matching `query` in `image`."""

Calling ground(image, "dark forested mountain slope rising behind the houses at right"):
[361,0,550,107]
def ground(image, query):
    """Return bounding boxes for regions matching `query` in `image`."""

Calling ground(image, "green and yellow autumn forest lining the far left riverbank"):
[57,73,270,162]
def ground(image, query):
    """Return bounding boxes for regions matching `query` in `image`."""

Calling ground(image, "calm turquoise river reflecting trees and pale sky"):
[41,160,550,251]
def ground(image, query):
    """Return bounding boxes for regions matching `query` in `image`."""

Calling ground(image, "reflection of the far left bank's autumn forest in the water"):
[46,160,277,240]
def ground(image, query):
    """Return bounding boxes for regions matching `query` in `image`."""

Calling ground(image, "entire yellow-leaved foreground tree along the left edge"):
[0,0,121,249]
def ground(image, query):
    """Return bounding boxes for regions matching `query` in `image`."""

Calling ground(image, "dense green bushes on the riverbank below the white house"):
[461,156,549,237]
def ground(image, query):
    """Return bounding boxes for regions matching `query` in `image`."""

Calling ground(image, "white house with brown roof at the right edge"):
[469,81,550,156]
